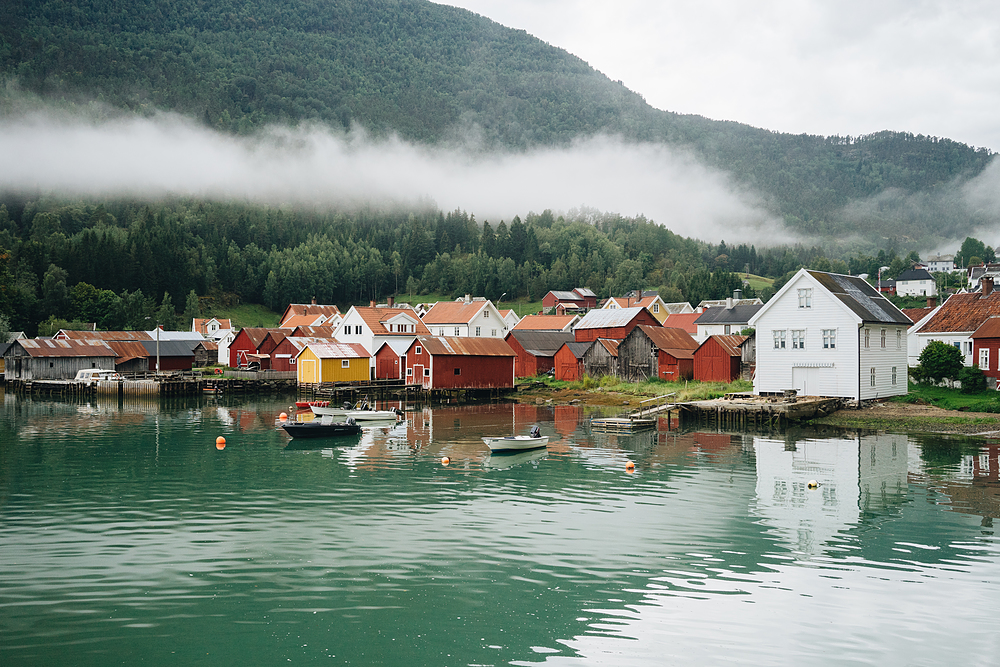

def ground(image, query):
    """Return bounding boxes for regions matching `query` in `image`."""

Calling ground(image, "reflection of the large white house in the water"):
[751,434,909,554]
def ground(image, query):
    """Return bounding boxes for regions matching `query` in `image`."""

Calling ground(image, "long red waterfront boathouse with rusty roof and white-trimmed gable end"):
[402,336,517,389]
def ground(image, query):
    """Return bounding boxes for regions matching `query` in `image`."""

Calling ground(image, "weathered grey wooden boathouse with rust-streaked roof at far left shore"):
[4,338,117,381]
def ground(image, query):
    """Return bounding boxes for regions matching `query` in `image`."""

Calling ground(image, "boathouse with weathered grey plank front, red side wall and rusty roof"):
[618,325,698,382]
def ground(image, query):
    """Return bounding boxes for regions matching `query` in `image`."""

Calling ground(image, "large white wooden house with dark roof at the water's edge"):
[750,269,910,401]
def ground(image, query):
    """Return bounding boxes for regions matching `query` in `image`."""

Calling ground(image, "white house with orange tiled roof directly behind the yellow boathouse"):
[334,305,431,377]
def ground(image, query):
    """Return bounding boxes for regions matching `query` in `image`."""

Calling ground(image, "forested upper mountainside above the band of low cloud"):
[0,0,992,245]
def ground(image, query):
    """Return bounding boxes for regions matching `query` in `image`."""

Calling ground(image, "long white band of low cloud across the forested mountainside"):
[0,111,797,245]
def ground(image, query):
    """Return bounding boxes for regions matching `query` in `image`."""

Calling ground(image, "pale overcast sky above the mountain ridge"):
[442,0,1000,151]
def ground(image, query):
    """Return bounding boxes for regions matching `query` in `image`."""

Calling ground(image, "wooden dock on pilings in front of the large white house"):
[678,391,843,429]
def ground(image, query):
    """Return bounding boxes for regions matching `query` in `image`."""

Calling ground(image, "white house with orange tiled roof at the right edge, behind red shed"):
[909,276,1000,366]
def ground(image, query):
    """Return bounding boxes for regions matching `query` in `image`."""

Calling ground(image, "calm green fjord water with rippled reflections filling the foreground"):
[0,395,1000,665]
